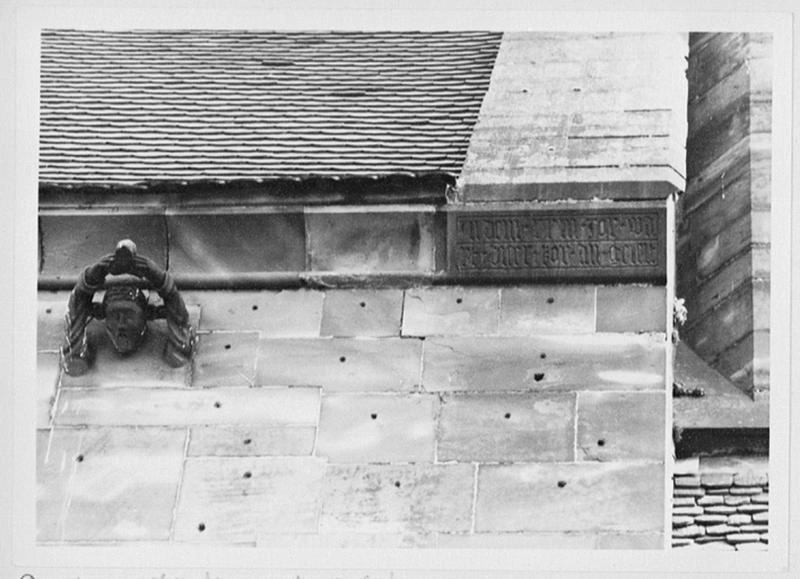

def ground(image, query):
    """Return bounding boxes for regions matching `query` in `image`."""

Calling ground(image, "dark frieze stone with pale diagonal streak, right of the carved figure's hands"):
[167,209,305,274]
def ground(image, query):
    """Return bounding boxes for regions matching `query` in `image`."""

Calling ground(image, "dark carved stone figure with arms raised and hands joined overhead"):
[61,239,195,376]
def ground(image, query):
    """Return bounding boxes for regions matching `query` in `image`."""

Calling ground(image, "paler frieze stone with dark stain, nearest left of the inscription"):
[306,211,435,272]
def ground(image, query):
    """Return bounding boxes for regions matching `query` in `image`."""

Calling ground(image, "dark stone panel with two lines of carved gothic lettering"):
[448,208,666,281]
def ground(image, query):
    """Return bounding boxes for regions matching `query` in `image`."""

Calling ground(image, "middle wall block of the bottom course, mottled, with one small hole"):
[320,463,475,534]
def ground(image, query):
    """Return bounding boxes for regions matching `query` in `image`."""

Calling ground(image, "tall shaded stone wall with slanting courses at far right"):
[677,33,772,397]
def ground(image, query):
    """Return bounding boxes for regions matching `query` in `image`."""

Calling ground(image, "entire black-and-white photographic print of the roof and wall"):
[3,2,791,579]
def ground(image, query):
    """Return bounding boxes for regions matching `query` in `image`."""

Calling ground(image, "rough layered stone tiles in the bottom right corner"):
[672,457,769,551]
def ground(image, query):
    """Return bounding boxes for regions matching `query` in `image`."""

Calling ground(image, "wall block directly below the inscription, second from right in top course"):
[498,285,595,336]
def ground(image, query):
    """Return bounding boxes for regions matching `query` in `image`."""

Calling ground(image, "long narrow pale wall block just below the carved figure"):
[55,387,319,426]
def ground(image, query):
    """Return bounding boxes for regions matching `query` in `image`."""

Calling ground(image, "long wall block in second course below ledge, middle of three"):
[256,338,422,392]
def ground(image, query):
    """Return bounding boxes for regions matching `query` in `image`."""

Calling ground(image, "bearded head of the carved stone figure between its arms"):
[103,286,147,354]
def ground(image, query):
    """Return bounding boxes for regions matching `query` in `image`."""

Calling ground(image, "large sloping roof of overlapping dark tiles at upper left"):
[40,30,501,184]
